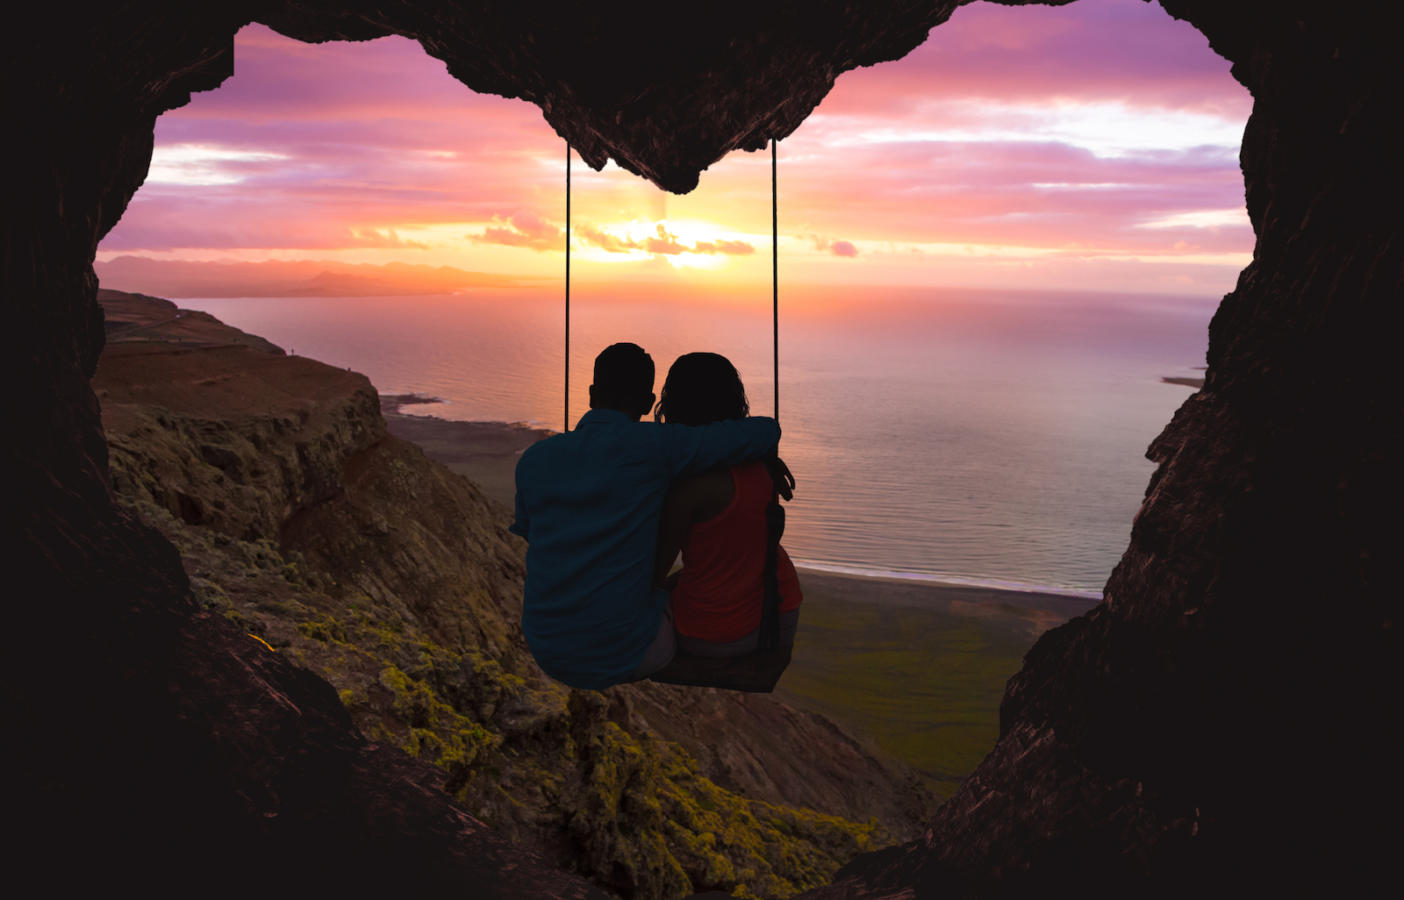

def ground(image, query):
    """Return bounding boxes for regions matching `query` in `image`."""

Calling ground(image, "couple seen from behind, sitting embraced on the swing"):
[510,343,800,689]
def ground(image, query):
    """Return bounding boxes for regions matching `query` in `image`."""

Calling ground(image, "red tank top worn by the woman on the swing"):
[673,461,802,643]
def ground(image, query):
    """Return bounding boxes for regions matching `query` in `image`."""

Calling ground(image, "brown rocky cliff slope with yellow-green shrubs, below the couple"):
[93,291,934,897]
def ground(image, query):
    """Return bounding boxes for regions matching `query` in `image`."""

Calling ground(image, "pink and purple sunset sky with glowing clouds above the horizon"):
[97,0,1252,296]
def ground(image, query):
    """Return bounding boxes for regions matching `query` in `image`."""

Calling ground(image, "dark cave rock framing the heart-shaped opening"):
[0,0,1404,897]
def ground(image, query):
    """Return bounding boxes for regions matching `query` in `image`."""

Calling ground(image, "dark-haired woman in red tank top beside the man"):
[654,352,802,657]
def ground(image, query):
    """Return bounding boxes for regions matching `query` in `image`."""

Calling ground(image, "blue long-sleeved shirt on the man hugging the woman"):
[511,410,781,689]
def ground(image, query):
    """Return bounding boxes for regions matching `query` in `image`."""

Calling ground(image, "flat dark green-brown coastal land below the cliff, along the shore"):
[380,395,1097,796]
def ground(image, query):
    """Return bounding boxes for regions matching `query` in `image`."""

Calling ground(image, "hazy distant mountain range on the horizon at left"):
[93,256,538,298]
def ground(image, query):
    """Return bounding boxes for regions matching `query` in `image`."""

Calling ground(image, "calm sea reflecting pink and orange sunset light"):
[180,286,1219,598]
